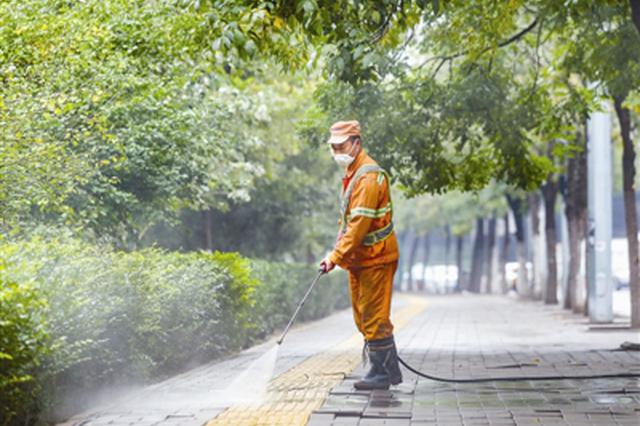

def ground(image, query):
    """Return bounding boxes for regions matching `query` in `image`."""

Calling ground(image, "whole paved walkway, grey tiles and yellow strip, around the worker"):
[57,295,640,426]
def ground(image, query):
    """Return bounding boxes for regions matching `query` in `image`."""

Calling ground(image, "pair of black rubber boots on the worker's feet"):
[354,336,402,390]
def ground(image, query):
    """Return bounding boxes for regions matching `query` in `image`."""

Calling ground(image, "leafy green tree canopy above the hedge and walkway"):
[0,0,640,260]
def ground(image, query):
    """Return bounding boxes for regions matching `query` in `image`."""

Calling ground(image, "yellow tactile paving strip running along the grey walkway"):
[207,295,426,426]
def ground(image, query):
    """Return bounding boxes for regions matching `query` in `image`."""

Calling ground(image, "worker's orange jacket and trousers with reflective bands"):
[329,149,398,341]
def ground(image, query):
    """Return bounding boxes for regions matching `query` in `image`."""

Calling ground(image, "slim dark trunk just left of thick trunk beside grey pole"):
[542,173,558,305]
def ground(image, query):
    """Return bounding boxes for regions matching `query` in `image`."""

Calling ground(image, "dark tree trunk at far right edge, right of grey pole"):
[614,97,640,328]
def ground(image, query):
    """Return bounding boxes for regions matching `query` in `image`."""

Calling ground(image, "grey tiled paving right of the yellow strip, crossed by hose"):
[308,295,640,426]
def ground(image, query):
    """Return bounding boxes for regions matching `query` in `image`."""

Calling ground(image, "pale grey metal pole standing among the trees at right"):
[587,107,613,323]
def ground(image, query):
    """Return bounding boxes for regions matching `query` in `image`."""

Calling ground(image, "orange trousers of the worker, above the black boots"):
[349,262,398,341]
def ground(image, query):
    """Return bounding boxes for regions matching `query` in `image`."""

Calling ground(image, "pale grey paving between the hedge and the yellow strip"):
[60,302,364,426]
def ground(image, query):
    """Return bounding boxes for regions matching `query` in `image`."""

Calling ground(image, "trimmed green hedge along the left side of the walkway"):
[0,238,348,425]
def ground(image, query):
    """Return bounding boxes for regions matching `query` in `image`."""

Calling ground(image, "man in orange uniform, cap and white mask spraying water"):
[320,121,402,390]
